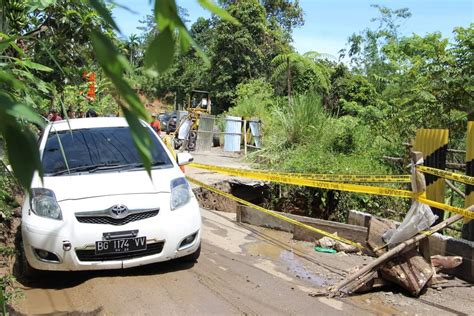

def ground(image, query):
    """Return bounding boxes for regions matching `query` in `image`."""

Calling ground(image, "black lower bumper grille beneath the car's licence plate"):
[76,241,165,261]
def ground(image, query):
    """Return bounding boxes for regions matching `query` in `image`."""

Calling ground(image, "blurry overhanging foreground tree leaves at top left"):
[0,0,237,189]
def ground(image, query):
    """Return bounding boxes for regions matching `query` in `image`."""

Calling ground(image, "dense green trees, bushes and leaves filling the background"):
[0,0,474,217]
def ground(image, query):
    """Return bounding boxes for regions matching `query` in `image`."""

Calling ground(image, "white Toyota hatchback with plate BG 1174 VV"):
[21,118,201,274]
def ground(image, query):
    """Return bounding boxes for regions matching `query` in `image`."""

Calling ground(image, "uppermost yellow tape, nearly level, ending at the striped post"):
[190,163,410,183]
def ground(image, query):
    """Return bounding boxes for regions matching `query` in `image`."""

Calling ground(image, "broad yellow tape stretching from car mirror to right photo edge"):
[189,163,474,219]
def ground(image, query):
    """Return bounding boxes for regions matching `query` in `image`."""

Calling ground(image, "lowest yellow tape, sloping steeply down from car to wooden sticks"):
[186,176,364,249]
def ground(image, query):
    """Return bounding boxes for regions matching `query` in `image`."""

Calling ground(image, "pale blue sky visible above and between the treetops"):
[113,0,474,56]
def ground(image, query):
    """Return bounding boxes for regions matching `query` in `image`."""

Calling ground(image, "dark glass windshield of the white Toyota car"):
[42,127,172,175]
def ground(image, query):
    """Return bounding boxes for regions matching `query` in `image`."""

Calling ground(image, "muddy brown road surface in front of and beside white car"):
[12,210,372,315]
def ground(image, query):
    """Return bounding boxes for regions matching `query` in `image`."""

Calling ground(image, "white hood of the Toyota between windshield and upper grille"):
[32,168,184,201]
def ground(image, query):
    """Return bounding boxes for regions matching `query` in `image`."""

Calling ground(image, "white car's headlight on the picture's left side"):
[30,188,63,220]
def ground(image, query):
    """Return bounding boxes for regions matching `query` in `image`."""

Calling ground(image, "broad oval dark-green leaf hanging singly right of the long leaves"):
[145,27,175,72]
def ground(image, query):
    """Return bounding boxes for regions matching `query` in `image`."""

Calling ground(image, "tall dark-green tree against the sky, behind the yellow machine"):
[209,0,278,111]
